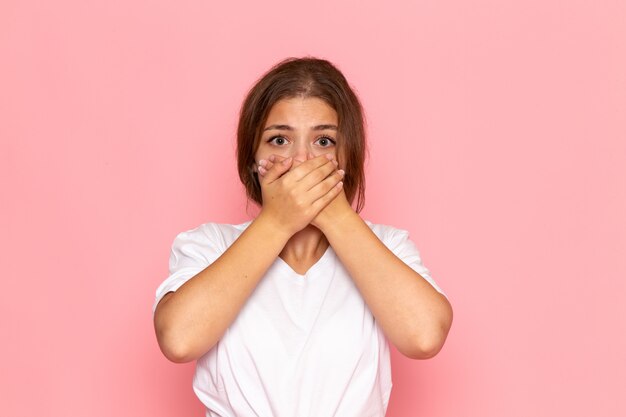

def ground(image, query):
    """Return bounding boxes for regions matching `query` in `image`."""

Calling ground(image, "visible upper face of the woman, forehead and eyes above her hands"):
[254,97,341,169]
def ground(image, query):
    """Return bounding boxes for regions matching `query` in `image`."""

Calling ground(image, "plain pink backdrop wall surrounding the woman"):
[0,0,626,417]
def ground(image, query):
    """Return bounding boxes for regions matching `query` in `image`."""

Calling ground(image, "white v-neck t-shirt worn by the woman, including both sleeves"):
[152,220,443,417]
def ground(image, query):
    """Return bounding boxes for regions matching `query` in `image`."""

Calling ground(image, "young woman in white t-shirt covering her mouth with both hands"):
[153,57,452,417]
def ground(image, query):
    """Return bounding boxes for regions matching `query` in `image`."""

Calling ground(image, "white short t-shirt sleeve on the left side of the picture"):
[152,223,223,316]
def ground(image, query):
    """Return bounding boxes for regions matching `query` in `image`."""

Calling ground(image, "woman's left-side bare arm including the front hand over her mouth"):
[154,156,341,362]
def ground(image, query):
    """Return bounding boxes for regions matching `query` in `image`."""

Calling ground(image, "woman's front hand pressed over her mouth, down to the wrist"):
[259,154,343,236]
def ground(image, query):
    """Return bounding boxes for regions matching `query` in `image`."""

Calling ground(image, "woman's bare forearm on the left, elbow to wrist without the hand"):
[154,214,290,362]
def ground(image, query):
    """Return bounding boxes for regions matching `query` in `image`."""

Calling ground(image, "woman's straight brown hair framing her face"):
[237,57,367,213]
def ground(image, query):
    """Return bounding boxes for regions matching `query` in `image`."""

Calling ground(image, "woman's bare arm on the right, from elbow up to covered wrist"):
[313,191,452,359]
